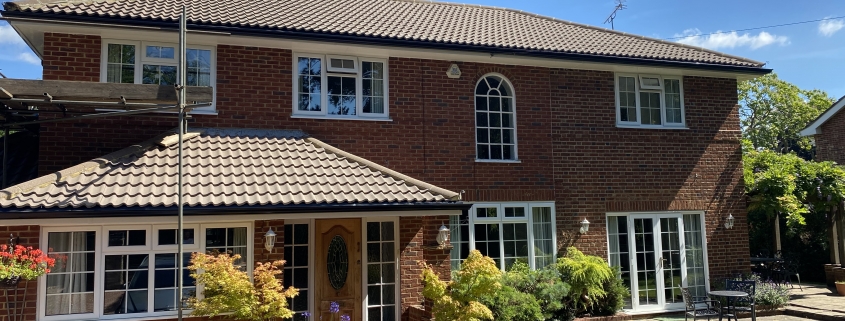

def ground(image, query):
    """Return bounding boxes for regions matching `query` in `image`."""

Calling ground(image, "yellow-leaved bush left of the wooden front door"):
[188,253,299,321]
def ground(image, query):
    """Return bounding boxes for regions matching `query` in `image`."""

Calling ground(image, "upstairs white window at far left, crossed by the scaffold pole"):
[100,39,216,113]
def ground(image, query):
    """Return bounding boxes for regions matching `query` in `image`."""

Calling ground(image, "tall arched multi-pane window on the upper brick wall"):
[475,74,517,160]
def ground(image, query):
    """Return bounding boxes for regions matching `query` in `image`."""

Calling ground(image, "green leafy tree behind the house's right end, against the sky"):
[737,73,833,159]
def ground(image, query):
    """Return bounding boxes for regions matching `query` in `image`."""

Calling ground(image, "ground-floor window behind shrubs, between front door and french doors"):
[449,203,556,271]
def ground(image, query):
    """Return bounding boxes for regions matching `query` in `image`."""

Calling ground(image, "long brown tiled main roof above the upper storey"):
[1,0,763,67]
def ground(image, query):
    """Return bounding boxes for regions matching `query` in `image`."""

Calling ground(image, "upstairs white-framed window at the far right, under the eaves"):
[616,74,686,128]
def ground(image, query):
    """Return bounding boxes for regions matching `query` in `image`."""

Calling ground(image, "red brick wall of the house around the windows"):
[28,33,752,319]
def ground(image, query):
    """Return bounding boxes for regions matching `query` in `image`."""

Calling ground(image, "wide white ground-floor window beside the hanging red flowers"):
[37,222,253,321]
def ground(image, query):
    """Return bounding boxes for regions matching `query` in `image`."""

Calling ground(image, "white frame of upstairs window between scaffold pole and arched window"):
[291,52,391,121]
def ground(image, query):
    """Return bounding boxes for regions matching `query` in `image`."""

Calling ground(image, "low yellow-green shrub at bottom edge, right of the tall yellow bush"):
[482,285,545,321]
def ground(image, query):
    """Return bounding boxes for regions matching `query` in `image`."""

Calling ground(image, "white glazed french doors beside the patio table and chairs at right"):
[608,214,706,312]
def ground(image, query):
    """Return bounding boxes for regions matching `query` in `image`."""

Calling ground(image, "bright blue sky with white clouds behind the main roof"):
[0,0,845,98]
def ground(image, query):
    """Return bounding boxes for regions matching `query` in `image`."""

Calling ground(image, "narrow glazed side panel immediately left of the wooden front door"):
[284,221,311,321]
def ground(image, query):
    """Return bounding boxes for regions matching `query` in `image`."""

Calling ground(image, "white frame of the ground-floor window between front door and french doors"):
[467,202,557,271]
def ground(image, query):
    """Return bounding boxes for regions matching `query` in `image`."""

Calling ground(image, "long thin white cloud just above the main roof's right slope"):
[675,29,789,50]
